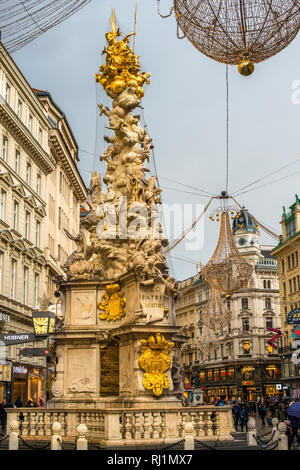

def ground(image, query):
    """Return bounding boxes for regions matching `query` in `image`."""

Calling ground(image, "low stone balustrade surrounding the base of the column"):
[6,406,234,446]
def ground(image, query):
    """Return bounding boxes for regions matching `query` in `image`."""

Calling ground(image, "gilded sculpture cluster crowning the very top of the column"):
[95,9,150,99]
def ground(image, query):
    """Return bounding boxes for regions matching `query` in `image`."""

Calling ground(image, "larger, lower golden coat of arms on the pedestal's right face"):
[138,333,174,397]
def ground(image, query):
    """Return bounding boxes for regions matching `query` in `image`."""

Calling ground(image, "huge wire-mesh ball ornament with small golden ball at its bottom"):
[171,0,300,76]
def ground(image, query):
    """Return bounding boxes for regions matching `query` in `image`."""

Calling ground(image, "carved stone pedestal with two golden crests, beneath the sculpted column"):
[48,275,183,409]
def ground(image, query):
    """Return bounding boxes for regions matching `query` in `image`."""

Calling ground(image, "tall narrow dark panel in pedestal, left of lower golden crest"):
[100,342,119,397]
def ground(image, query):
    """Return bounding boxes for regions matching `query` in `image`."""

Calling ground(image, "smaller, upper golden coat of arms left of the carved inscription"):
[98,284,126,321]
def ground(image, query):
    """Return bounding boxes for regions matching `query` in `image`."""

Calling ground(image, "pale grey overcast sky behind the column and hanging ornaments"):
[8,0,300,279]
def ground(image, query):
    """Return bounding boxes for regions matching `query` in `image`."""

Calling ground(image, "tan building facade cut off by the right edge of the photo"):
[272,195,300,399]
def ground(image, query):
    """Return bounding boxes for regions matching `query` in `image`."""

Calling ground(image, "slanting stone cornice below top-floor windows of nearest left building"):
[0,95,55,175]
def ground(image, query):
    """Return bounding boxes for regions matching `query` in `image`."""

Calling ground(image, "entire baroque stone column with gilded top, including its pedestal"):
[49,11,184,408]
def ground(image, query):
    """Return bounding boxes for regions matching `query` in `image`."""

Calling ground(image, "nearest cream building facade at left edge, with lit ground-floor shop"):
[0,45,55,401]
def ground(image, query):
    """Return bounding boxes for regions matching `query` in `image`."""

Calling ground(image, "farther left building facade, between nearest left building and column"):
[34,89,87,303]
